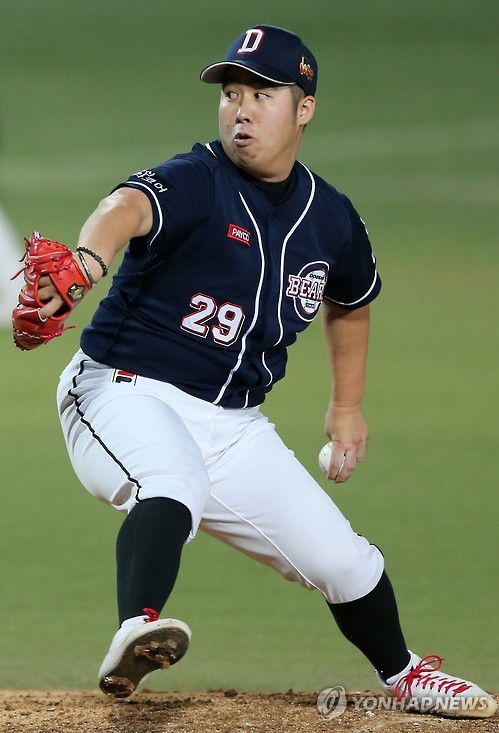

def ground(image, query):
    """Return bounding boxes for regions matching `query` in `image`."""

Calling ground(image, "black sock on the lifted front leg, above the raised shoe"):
[116,498,191,625]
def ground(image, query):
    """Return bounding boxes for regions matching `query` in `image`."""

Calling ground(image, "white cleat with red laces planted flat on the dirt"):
[376,652,497,718]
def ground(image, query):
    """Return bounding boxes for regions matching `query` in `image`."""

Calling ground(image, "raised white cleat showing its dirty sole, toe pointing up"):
[99,609,191,697]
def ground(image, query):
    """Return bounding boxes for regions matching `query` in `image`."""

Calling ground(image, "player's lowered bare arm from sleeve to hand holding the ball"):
[322,300,370,483]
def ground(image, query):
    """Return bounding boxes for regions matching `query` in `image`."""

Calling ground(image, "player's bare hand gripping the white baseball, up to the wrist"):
[325,404,369,484]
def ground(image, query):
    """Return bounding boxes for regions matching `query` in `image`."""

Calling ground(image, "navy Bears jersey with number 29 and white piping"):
[81,141,381,408]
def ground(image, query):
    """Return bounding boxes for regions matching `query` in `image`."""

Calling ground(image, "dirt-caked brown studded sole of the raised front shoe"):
[99,626,190,698]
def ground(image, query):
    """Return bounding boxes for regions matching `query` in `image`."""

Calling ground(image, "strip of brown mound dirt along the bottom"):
[0,690,499,733]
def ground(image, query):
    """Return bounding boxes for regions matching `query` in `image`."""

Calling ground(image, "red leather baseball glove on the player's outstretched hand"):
[12,232,92,351]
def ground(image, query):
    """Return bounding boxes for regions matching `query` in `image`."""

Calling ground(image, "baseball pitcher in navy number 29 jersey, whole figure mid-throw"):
[14,25,496,717]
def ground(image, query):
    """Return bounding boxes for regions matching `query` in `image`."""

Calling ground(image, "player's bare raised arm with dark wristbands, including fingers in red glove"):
[38,187,153,318]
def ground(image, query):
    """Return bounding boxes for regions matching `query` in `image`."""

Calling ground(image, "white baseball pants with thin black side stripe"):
[57,351,384,603]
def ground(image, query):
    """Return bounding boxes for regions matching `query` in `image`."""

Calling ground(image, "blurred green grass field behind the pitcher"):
[0,0,499,690]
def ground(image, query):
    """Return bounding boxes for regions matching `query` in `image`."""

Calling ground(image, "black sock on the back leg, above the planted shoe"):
[327,572,410,680]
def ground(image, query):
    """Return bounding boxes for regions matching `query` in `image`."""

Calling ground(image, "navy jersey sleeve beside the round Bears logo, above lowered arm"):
[324,196,381,310]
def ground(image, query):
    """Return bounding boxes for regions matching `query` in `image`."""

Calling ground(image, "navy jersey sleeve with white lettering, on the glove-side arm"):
[115,155,213,253]
